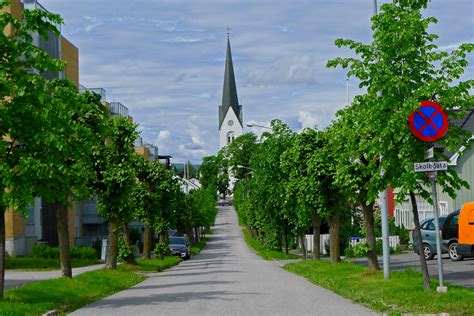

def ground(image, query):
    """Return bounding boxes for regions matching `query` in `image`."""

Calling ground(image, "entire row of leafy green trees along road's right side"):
[221,0,474,289]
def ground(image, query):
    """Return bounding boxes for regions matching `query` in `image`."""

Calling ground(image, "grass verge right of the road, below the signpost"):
[284,260,474,315]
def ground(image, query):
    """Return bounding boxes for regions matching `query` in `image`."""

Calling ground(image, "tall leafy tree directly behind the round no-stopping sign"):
[328,0,474,289]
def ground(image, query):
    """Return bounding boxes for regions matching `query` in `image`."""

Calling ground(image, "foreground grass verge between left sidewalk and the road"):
[0,269,144,315]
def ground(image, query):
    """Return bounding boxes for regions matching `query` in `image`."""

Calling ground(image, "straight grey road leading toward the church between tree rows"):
[72,207,372,316]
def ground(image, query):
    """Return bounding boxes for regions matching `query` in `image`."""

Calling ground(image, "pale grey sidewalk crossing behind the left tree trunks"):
[5,263,105,291]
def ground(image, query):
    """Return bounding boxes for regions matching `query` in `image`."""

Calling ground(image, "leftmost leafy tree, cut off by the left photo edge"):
[0,1,81,297]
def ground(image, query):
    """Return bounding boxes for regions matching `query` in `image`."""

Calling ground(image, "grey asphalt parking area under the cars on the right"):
[351,252,474,290]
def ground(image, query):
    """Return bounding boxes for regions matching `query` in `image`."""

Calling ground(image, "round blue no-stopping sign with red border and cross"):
[408,101,449,142]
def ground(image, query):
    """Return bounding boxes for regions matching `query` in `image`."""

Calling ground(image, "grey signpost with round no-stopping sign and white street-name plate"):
[408,101,448,293]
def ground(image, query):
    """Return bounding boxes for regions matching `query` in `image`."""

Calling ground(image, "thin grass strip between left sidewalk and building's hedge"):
[5,257,100,271]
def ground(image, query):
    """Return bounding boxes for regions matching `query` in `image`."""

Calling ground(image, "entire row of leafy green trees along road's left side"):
[0,1,216,297]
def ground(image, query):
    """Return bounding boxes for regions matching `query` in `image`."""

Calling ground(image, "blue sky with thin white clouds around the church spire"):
[39,0,474,163]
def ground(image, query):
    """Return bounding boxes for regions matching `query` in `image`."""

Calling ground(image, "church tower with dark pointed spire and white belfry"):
[219,36,243,148]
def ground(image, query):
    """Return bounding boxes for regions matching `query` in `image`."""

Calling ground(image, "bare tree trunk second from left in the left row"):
[54,203,72,278]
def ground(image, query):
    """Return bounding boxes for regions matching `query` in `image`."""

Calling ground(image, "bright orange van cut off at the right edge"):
[457,202,474,257]
